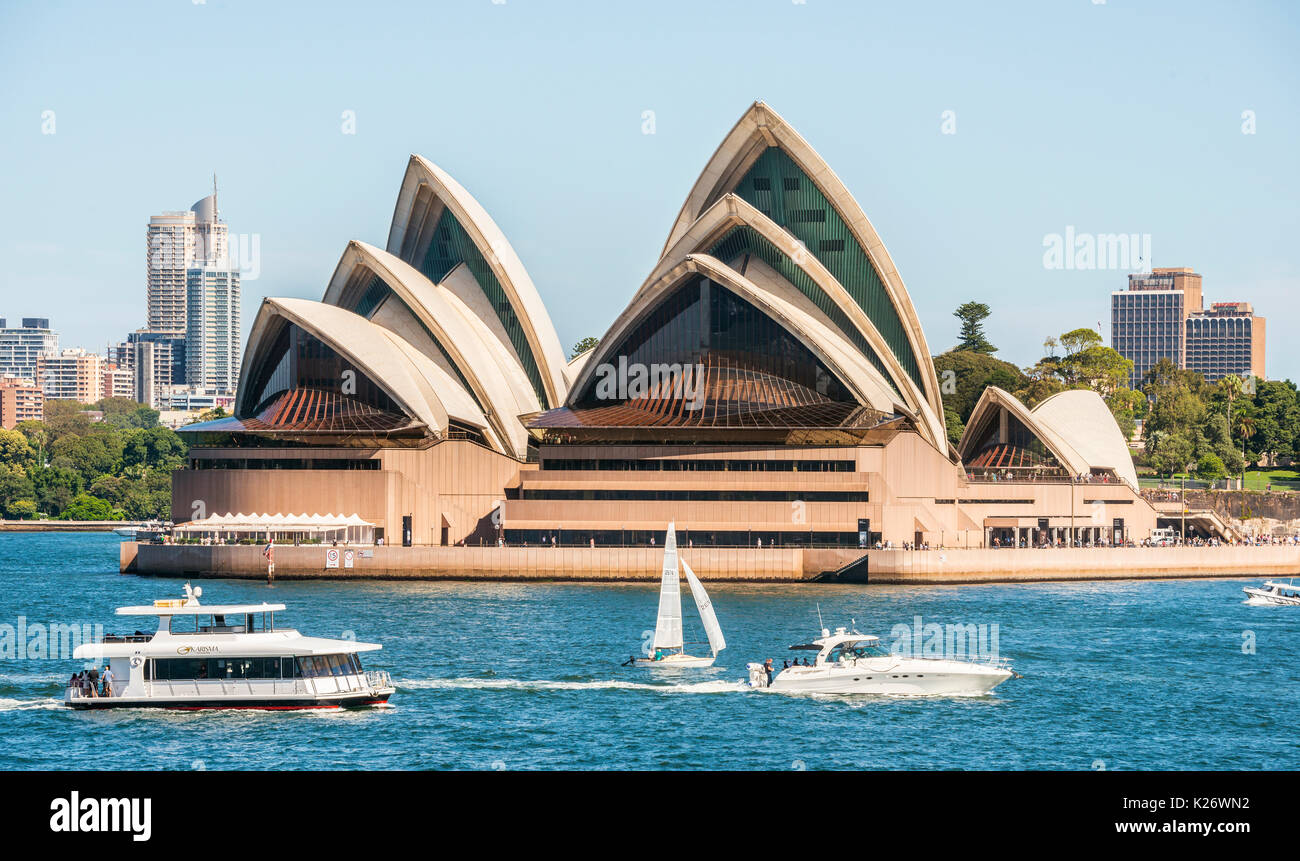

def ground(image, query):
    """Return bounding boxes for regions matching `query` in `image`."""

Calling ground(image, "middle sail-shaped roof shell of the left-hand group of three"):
[324,241,541,458]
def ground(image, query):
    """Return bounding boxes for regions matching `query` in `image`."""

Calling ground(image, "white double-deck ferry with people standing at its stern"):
[64,583,394,710]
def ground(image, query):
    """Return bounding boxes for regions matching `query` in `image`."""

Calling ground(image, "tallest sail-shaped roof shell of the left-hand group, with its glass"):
[387,155,566,408]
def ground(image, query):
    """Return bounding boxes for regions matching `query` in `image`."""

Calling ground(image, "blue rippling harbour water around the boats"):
[0,533,1300,770]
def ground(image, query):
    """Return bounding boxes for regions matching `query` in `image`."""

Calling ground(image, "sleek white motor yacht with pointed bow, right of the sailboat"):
[748,628,1018,696]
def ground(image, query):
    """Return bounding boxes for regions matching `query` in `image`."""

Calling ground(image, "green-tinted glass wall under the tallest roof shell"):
[733,147,926,391]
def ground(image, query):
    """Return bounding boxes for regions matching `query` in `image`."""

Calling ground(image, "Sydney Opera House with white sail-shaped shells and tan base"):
[173,103,1156,548]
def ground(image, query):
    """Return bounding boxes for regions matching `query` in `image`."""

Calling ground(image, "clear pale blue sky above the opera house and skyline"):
[0,0,1300,378]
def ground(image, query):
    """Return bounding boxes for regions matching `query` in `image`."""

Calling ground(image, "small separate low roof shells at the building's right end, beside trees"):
[957,386,1138,489]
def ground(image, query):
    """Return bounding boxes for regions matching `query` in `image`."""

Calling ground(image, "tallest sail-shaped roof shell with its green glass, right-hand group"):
[664,101,944,426]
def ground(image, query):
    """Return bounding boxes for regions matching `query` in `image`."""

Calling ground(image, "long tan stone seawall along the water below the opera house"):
[121,541,1300,584]
